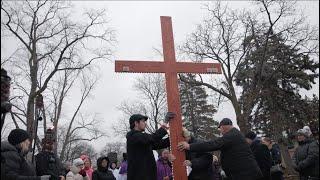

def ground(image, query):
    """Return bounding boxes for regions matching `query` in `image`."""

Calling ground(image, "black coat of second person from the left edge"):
[35,151,64,180]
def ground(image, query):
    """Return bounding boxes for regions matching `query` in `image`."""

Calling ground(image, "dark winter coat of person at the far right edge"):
[292,140,319,177]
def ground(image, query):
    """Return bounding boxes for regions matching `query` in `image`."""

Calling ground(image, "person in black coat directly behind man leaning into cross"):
[245,131,272,180]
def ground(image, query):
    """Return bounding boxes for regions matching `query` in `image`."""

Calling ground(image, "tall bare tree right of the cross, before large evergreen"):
[180,0,318,132]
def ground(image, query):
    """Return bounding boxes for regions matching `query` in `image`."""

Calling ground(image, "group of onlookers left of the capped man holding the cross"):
[1,129,127,180]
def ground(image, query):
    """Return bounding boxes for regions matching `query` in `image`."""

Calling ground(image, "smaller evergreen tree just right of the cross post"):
[180,74,219,140]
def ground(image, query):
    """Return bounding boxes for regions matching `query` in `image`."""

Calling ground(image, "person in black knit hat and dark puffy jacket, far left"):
[1,129,50,180]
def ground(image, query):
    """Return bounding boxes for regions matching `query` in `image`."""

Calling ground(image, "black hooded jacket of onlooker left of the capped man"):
[92,157,116,180]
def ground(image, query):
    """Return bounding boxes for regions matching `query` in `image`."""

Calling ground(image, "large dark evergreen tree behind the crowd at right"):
[236,35,319,139]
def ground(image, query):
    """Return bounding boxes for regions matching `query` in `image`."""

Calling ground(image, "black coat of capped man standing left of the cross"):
[126,128,170,180]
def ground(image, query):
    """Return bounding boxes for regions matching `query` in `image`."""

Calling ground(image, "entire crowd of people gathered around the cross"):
[1,69,319,180]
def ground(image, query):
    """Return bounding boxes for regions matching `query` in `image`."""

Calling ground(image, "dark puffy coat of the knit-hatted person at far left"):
[1,141,40,180]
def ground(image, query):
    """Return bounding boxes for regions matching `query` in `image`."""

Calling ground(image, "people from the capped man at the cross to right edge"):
[122,113,319,180]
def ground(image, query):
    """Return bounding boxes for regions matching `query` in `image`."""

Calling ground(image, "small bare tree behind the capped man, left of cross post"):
[113,74,167,135]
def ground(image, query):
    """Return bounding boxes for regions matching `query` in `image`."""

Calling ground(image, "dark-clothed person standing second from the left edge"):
[35,138,65,180]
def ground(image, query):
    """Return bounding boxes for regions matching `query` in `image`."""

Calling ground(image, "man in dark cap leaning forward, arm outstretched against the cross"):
[178,118,262,180]
